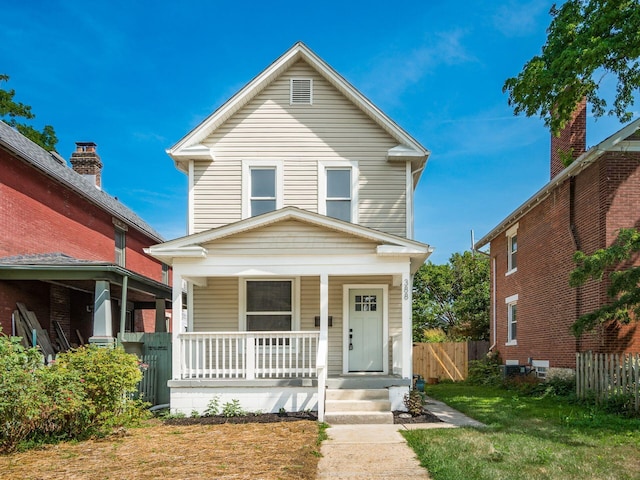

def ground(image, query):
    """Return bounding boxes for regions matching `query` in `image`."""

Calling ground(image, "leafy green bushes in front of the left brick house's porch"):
[0,332,146,451]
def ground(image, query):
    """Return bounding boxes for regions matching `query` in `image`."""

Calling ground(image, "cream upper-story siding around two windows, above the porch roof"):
[193,61,407,236]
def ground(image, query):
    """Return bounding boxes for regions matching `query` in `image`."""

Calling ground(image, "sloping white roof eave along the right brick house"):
[474,118,640,249]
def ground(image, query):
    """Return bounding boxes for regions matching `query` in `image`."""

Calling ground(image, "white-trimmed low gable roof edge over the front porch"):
[145,203,433,262]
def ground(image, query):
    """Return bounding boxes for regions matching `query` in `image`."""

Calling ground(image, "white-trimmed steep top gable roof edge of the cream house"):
[167,42,430,183]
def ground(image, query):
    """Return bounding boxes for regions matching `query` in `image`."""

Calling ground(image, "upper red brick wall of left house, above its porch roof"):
[0,150,162,281]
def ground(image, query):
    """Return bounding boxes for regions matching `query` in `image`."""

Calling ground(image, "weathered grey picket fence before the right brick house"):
[576,352,640,410]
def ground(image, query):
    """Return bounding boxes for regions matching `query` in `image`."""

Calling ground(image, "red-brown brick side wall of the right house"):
[491,153,640,367]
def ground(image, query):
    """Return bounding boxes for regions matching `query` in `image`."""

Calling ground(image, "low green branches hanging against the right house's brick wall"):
[569,228,640,336]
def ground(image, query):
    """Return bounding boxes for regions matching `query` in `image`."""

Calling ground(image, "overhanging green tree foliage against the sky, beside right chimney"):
[503,0,640,135]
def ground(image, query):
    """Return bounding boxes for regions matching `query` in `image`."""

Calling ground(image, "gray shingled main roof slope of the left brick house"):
[0,121,164,243]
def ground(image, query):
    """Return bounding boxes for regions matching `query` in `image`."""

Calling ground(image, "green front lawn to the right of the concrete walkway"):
[403,383,640,480]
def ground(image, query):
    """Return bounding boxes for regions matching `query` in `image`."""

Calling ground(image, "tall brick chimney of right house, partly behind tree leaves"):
[551,98,587,179]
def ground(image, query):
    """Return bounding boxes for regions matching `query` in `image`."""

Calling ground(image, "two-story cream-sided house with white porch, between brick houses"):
[148,43,432,421]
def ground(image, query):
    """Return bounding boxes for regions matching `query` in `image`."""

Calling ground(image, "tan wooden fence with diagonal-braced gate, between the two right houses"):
[413,341,489,381]
